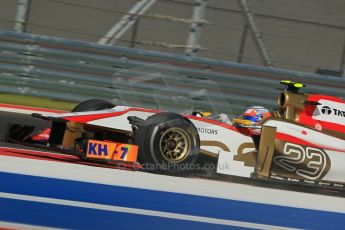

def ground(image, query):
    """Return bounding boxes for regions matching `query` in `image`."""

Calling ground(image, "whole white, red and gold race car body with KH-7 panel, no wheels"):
[4,81,345,189]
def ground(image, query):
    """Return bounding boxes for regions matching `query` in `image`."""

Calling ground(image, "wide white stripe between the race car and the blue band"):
[0,156,345,213]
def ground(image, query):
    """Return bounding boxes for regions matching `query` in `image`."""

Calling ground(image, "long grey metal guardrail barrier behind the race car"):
[0,31,345,113]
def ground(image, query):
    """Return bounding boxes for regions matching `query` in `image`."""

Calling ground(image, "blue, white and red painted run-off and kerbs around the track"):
[0,104,345,229]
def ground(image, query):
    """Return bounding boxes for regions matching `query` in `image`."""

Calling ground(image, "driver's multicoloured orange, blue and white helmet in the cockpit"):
[233,106,271,128]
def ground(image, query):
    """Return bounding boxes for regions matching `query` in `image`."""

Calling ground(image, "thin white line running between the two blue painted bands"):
[0,192,291,229]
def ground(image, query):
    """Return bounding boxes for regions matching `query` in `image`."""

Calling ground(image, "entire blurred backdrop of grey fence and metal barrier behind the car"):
[0,0,345,114]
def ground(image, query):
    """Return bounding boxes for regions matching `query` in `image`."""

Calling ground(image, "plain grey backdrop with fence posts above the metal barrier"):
[0,0,345,76]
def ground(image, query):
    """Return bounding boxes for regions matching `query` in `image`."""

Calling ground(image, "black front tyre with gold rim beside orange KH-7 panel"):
[135,113,200,175]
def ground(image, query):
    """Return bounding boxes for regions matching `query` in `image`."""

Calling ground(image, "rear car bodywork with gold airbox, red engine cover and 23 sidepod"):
[250,83,345,188]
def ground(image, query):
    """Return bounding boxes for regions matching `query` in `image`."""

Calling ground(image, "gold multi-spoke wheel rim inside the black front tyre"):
[160,128,190,163]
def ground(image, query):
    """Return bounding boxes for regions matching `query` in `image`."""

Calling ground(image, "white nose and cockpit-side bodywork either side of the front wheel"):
[48,106,255,177]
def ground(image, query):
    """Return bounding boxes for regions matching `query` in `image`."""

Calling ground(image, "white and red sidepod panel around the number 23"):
[265,120,345,181]
